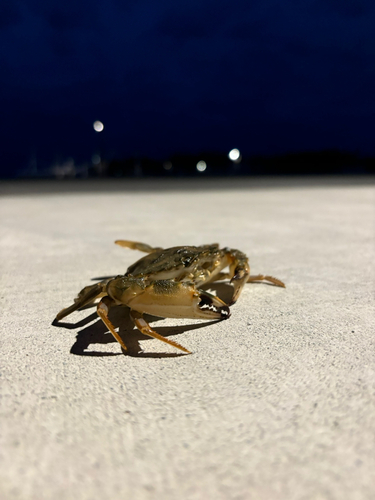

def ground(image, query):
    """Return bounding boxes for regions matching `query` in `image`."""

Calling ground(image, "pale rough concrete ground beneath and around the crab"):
[0,178,375,500]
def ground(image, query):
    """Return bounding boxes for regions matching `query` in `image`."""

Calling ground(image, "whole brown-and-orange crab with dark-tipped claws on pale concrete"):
[55,240,285,354]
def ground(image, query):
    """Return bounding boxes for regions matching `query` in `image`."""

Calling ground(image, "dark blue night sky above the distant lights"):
[0,0,375,175]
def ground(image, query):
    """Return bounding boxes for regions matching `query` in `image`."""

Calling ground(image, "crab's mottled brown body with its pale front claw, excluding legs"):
[107,245,249,319]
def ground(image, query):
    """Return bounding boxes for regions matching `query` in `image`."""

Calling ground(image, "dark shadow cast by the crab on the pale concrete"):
[52,283,233,358]
